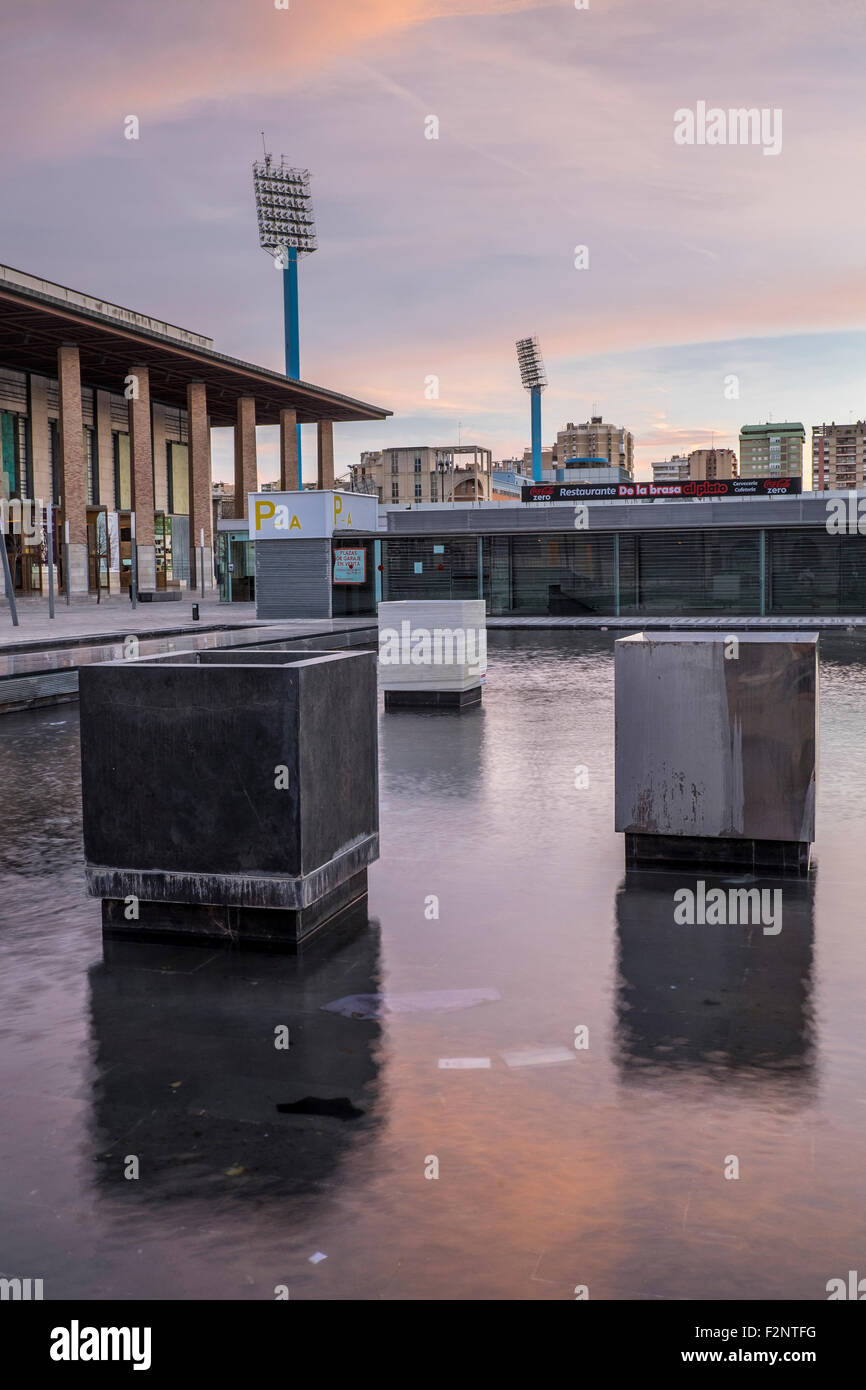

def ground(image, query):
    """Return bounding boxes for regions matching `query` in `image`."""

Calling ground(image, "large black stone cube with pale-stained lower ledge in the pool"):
[79,649,378,945]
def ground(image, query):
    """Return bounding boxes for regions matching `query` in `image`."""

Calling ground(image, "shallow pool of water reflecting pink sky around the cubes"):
[0,631,866,1300]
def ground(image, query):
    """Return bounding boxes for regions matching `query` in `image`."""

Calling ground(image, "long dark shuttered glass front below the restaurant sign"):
[382,527,866,617]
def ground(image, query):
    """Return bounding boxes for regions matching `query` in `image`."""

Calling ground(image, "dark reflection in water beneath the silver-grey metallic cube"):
[616,870,815,1087]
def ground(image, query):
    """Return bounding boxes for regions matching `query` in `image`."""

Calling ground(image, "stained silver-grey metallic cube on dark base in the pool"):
[616,632,817,874]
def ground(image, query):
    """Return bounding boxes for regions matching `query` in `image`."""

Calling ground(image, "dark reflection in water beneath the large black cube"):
[89,910,381,1204]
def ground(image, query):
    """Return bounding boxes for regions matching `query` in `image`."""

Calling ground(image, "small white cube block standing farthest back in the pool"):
[378,599,487,710]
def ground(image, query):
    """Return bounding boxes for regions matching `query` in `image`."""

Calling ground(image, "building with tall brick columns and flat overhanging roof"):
[0,265,391,595]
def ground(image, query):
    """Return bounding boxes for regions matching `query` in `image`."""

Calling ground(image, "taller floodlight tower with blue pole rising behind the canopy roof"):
[253,152,318,469]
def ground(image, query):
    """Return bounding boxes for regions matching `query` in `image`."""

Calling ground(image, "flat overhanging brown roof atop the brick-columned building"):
[0,271,392,425]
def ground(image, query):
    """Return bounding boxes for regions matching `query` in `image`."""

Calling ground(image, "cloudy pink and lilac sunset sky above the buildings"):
[0,0,866,481]
